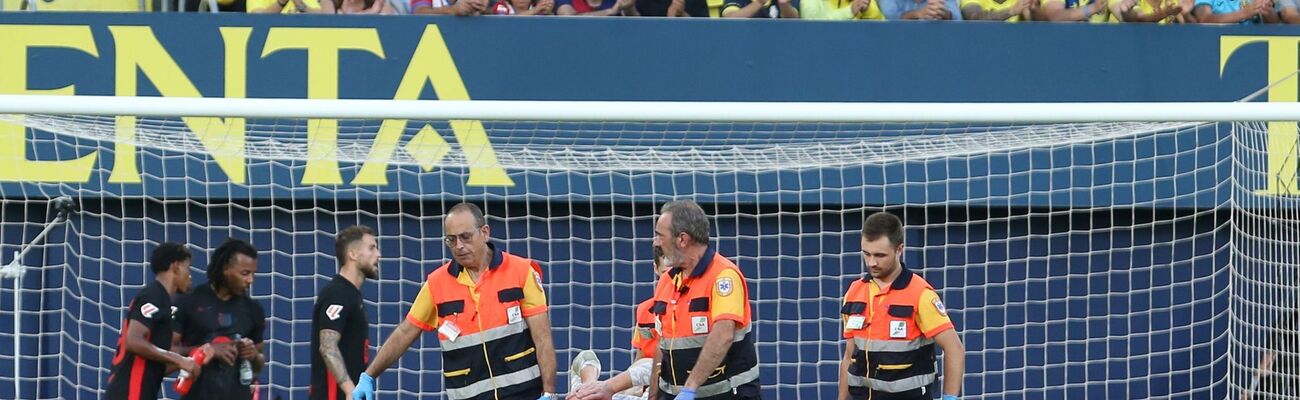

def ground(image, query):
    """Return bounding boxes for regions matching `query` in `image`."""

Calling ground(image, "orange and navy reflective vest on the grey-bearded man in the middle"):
[650,249,758,399]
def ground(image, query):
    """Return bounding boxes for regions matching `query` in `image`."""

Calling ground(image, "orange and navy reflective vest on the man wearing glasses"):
[428,249,542,400]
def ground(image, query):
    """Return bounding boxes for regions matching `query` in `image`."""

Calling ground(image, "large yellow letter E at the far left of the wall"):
[0,25,99,183]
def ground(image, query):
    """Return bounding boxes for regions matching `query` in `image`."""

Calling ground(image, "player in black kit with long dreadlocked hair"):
[173,239,267,400]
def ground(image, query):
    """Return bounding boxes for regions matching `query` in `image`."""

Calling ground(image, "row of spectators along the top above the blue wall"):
[7,0,1300,25]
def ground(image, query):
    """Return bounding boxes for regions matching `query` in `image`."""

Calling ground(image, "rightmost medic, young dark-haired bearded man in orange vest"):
[839,212,966,400]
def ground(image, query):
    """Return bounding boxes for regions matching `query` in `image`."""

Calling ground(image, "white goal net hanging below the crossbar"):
[0,100,1300,399]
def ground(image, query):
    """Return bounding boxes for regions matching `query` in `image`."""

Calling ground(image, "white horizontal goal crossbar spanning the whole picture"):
[0,95,1300,123]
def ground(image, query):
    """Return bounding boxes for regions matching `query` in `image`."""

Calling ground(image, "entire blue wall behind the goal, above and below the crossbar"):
[0,14,1300,399]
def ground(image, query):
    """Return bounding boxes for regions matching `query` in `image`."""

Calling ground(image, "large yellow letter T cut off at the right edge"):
[1219,36,1300,196]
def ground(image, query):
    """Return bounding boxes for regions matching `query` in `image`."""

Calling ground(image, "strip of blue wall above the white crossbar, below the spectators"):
[3,13,1300,101]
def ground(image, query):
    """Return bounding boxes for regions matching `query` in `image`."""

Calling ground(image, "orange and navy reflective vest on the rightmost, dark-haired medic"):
[841,269,937,392]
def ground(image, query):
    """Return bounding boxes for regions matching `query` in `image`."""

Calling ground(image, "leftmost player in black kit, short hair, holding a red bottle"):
[104,243,199,400]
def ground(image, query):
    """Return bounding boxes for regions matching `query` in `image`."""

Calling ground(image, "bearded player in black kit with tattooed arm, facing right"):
[309,225,380,400]
